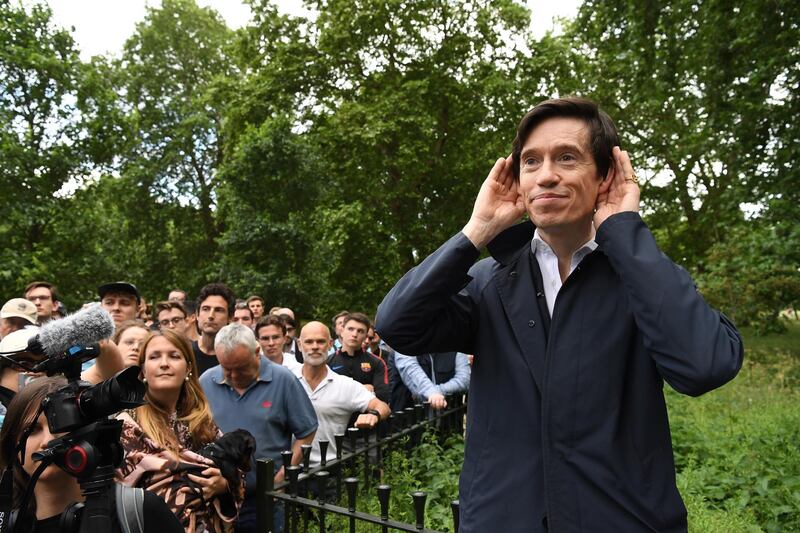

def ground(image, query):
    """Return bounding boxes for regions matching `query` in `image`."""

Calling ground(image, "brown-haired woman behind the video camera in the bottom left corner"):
[0,377,183,533]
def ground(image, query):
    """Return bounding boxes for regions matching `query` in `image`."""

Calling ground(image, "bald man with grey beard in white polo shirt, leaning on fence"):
[298,322,390,465]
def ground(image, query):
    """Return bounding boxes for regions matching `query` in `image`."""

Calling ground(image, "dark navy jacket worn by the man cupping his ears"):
[376,212,743,533]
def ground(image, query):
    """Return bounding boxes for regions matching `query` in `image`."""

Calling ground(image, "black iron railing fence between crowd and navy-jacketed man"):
[256,396,466,533]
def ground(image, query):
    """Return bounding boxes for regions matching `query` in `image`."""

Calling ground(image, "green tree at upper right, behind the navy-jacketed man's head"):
[571,0,799,270]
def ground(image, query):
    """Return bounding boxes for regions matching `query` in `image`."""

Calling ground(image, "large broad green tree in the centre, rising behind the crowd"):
[219,0,556,316]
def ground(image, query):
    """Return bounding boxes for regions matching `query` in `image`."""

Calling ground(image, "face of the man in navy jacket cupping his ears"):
[519,117,610,236]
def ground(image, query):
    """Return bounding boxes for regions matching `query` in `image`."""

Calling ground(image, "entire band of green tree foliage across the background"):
[0,0,800,328]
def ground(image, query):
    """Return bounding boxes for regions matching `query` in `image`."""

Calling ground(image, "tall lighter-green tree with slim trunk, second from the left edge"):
[115,0,233,247]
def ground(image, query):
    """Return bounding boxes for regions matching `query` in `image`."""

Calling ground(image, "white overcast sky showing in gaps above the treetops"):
[47,0,580,59]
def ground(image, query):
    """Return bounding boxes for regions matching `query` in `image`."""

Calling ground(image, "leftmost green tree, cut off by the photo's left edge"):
[0,0,87,295]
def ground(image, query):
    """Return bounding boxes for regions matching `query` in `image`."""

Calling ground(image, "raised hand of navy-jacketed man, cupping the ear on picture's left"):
[461,155,525,250]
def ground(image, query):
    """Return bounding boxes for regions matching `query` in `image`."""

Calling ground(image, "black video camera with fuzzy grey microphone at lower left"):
[0,306,145,533]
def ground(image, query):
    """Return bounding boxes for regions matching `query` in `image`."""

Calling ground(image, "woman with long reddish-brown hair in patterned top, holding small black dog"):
[118,329,244,533]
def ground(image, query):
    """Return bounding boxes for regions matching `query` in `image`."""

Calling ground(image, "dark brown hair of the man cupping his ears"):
[511,97,619,181]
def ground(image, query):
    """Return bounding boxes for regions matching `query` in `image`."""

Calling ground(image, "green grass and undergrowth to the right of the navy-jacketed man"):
[667,323,800,533]
